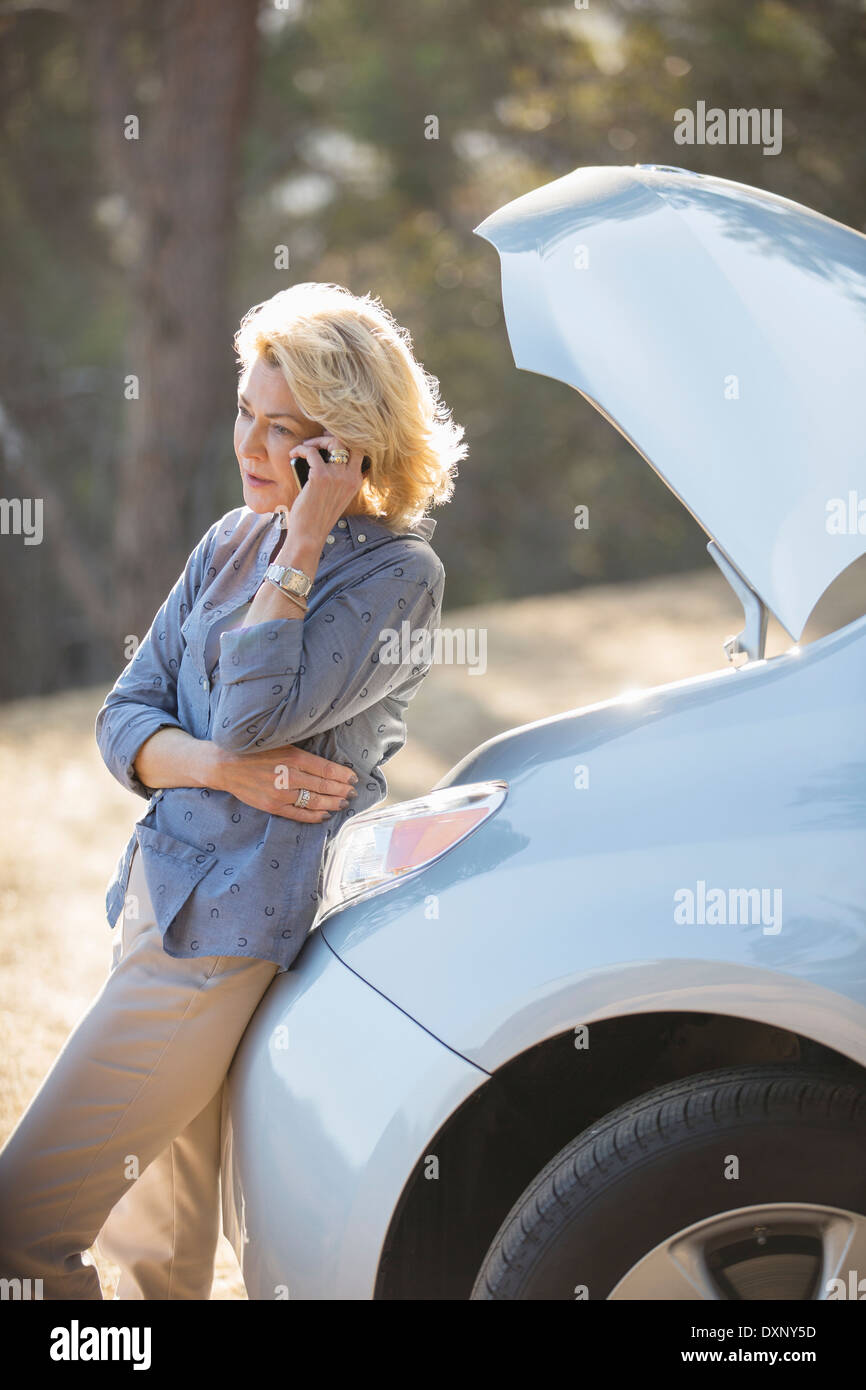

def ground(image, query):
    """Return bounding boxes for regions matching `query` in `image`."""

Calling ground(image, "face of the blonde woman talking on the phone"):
[235,357,325,513]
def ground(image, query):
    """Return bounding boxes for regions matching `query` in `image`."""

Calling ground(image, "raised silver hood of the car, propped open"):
[475,165,866,639]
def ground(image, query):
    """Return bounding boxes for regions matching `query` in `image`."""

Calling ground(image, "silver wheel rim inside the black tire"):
[607,1202,866,1301]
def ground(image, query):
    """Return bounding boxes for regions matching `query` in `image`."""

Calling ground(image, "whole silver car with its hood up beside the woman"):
[222,165,866,1300]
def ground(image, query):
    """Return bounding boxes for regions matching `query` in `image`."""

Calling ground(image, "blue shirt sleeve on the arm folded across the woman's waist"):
[96,523,218,798]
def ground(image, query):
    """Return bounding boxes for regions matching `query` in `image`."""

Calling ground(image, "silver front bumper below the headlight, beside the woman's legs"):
[222,933,487,1300]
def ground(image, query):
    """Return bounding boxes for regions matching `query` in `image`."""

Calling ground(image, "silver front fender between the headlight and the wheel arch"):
[320,619,866,1072]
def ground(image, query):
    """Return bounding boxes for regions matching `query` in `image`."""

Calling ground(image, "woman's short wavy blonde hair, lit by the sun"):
[235,281,468,530]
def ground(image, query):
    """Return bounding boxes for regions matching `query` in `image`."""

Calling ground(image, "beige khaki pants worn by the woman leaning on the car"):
[0,849,277,1300]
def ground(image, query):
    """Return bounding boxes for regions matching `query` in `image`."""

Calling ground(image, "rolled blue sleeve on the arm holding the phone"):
[210,571,443,753]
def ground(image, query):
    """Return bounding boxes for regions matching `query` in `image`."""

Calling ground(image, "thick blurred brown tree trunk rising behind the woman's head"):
[88,0,259,635]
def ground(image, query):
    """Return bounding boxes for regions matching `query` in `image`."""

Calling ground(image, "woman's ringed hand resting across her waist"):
[209,744,357,824]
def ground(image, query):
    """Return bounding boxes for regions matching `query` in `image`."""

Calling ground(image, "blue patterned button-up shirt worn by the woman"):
[96,507,445,973]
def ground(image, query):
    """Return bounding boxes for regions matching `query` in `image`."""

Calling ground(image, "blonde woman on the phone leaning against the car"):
[0,284,466,1300]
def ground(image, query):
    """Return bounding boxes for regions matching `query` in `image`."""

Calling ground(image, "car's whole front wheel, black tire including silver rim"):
[470,1063,866,1300]
